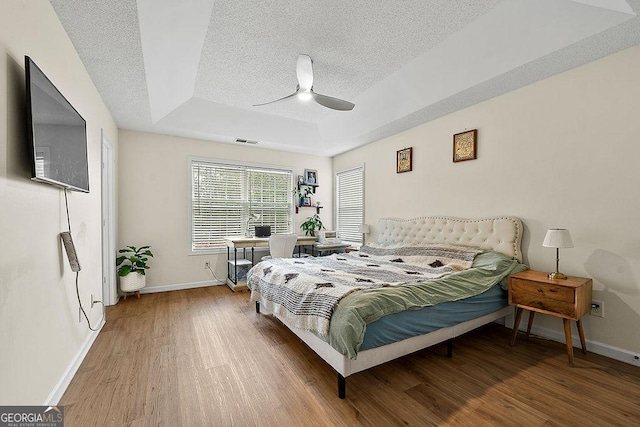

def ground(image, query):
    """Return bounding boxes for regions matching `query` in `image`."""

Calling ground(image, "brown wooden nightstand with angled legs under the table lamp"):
[509,270,593,366]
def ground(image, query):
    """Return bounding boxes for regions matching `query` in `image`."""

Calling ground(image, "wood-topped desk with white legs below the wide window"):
[224,236,316,291]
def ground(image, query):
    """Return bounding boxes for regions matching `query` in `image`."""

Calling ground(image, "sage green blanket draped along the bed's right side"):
[329,251,528,359]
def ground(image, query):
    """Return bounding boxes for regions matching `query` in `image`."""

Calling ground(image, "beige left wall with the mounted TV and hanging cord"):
[0,1,118,405]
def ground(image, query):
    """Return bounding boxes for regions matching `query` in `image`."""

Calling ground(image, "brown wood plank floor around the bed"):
[60,286,640,426]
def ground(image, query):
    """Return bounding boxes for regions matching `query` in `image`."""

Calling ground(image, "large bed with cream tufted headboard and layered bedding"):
[247,217,527,398]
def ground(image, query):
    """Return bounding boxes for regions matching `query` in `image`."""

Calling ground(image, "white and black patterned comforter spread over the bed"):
[247,245,482,341]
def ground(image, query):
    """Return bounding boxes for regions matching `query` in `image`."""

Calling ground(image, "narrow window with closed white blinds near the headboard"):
[336,166,364,245]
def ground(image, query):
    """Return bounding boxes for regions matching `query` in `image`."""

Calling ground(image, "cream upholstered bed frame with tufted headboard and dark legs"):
[256,217,522,399]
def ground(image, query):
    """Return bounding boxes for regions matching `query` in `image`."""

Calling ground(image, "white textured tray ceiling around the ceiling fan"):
[50,0,640,156]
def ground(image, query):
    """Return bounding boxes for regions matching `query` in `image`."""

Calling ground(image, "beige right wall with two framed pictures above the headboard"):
[334,47,640,352]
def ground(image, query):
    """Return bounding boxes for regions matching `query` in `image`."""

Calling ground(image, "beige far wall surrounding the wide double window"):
[118,130,333,288]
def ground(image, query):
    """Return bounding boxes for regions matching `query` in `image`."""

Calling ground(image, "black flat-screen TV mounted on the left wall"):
[24,56,89,193]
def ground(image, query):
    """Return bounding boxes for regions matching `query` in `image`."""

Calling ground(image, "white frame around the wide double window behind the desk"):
[187,156,295,255]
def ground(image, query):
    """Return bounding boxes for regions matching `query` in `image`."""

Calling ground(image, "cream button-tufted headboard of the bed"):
[375,216,522,261]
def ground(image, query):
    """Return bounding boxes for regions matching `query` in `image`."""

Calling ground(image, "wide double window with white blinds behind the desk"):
[189,158,293,253]
